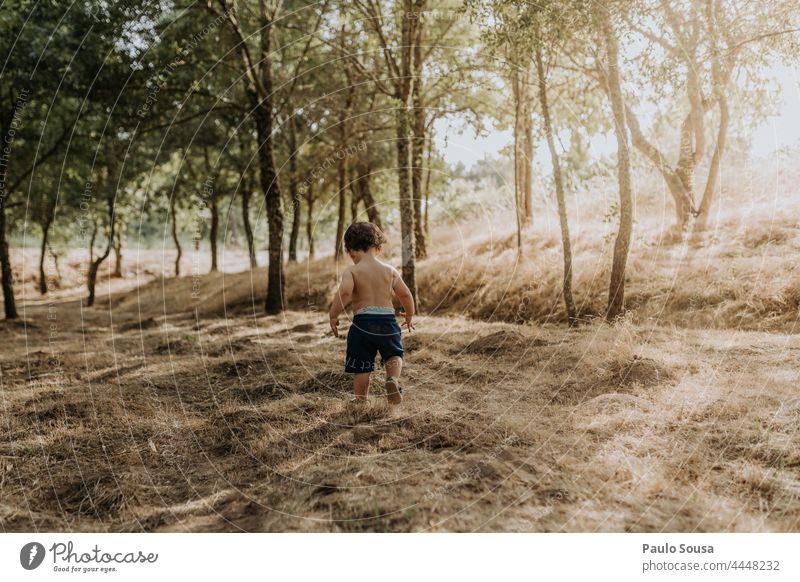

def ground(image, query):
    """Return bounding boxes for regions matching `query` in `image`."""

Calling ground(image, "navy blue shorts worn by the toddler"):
[344,313,403,374]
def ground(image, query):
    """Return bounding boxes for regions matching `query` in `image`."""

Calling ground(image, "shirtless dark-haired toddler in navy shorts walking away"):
[330,222,414,405]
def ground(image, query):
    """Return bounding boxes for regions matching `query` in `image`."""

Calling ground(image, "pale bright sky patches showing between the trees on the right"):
[436,65,800,167]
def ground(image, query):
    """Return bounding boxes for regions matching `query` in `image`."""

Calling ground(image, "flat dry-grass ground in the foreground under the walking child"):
[0,299,800,531]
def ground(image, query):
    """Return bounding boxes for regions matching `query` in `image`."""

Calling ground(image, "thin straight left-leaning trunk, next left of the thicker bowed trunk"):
[536,43,578,327]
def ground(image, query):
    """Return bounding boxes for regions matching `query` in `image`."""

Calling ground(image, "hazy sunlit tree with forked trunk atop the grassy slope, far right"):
[607,0,798,231]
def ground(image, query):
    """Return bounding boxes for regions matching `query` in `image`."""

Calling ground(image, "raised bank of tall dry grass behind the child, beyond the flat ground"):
[39,155,800,333]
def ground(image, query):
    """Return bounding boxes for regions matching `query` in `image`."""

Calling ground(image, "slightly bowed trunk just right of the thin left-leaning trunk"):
[597,8,633,321]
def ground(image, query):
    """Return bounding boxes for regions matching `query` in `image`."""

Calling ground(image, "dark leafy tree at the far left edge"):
[0,0,87,319]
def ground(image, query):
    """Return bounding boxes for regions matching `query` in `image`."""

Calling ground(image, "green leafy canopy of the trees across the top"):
[0,0,800,264]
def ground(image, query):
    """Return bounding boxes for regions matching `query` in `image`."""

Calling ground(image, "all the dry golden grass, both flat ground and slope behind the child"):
[0,157,800,531]
